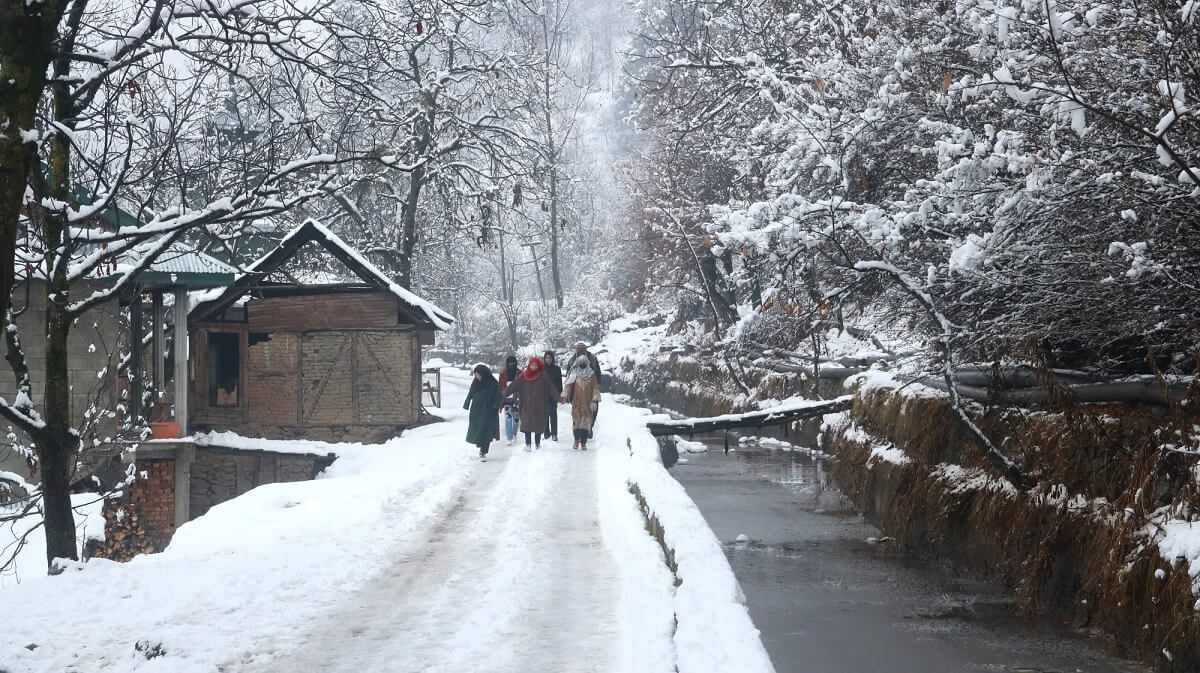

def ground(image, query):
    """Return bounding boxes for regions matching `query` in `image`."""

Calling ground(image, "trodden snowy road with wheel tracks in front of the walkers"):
[245,444,619,673]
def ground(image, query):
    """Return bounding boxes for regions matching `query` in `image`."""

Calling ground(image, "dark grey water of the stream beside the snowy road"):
[671,446,1147,673]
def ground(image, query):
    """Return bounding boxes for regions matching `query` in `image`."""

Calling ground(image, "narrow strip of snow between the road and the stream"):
[600,404,774,673]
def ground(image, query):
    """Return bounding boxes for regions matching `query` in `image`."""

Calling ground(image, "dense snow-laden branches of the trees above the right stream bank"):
[632,0,1200,372]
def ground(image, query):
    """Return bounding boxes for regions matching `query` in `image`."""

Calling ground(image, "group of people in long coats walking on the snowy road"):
[462,343,600,461]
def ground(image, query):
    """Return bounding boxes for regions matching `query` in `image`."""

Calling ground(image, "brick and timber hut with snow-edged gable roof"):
[188,220,454,441]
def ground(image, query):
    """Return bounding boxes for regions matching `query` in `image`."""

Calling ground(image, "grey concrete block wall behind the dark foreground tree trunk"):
[0,281,120,475]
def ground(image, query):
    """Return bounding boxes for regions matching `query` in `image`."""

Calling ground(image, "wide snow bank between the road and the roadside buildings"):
[0,367,473,673]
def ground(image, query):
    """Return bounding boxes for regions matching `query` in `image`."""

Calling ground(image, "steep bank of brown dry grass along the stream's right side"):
[827,379,1200,673]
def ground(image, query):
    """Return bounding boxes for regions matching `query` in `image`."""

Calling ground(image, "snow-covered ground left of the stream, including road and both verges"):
[0,369,772,673]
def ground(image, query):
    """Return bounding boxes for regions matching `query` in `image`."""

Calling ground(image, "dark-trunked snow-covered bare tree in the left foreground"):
[0,0,432,571]
